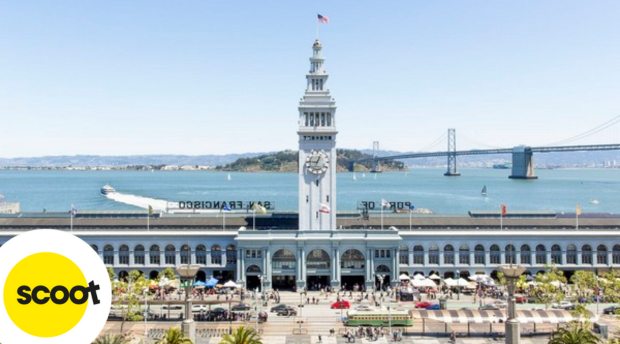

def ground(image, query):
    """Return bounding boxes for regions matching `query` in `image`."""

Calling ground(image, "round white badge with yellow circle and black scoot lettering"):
[0,231,111,344]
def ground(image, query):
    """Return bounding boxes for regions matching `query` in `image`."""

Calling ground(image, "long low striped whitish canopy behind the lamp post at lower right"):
[409,309,594,324]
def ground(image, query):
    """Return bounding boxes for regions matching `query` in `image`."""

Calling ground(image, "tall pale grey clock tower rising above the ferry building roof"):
[297,39,338,230]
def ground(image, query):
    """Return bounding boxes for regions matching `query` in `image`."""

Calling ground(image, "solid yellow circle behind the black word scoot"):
[4,252,89,338]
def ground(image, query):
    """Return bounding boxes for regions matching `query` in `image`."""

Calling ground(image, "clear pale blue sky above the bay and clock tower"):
[0,0,620,158]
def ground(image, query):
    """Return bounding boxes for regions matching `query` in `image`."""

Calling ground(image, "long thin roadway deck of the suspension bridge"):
[355,144,620,163]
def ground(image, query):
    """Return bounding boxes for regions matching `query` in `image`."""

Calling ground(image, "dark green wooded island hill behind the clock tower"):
[216,149,405,172]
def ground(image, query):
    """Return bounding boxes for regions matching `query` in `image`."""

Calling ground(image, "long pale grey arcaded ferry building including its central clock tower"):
[0,40,620,290]
